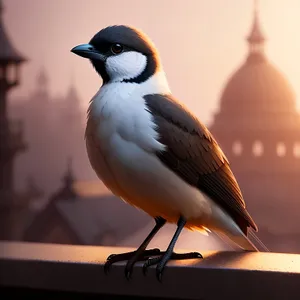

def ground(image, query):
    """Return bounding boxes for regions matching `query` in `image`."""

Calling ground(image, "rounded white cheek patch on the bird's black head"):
[106,51,147,82]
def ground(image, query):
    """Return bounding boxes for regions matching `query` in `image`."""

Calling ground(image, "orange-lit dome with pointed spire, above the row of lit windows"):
[211,3,300,132]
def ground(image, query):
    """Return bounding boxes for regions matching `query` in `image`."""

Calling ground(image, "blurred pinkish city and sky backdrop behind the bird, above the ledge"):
[0,0,300,253]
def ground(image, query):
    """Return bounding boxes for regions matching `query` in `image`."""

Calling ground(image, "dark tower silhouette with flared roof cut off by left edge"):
[0,0,26,239]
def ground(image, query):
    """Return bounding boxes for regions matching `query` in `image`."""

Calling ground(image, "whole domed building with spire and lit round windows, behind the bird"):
[210,4,300,252]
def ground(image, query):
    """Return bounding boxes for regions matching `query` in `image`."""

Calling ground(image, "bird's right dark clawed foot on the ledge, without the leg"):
[143,251,203,281]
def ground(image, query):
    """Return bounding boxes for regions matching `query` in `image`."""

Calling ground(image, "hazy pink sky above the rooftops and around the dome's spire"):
[3,0,300,122]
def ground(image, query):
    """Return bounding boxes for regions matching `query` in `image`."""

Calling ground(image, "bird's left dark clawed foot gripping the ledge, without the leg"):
[104,248,161,279]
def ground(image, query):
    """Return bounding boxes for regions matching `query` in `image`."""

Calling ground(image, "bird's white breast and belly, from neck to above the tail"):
[86,73,245,239]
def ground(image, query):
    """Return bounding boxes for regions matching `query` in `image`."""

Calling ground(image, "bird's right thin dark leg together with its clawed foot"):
[143,217,202,281]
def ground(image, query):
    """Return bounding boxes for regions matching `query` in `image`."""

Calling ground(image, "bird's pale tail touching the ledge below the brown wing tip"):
[215,229,270,252]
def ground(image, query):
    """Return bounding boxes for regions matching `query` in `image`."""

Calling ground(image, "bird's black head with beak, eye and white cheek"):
[71,25,160,84]
